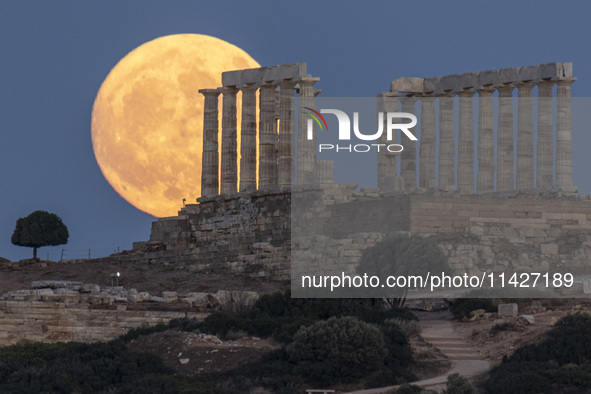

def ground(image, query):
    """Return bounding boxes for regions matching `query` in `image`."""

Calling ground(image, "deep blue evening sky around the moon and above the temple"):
[0,0,591,260]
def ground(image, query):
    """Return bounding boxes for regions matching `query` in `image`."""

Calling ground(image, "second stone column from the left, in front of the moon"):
[221,86,238,194]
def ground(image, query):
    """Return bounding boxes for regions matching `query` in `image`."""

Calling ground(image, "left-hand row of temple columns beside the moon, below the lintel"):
[199,77,328,196]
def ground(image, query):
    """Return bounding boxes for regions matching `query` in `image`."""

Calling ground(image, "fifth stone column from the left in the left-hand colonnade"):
[277,79,295,188]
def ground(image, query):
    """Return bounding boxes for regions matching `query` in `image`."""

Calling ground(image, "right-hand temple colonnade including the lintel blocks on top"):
[378,63,576,194]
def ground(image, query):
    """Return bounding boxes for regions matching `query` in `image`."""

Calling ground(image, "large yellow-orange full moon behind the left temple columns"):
[91,34,260,217]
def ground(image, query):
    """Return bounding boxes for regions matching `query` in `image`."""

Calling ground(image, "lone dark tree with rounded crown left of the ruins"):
[11,211,70,258]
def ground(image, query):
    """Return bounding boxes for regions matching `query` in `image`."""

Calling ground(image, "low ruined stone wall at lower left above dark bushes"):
[0,281,258,346]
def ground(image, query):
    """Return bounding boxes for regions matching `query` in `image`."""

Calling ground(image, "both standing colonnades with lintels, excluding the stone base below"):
[200,63,576,197]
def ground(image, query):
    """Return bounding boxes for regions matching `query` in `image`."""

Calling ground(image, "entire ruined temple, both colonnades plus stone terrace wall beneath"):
[127,63,591,294]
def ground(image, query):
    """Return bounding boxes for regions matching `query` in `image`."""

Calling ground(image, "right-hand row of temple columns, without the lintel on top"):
[378,78,575,193]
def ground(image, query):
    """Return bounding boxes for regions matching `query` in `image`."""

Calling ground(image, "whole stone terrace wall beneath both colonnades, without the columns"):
[104,184,591,288]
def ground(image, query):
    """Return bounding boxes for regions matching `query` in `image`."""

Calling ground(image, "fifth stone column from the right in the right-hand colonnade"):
[477,87,495,193]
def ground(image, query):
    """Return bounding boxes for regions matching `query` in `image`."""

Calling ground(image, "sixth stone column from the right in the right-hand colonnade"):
[458,90,474,194]
